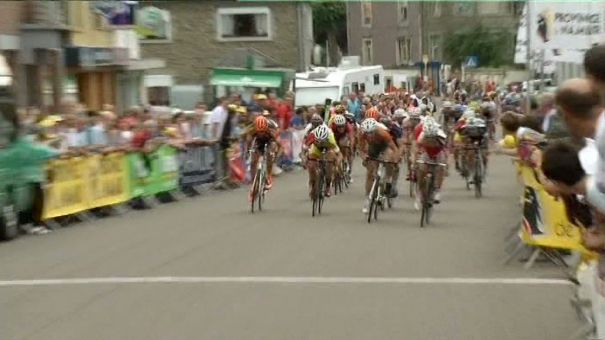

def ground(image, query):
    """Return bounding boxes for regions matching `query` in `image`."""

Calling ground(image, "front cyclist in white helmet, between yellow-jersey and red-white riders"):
[359,118,401,214]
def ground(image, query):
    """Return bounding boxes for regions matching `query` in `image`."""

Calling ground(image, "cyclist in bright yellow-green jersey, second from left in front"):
[307,124,342,199]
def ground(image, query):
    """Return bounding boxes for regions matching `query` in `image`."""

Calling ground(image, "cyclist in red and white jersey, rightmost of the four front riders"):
[414,116,447,209]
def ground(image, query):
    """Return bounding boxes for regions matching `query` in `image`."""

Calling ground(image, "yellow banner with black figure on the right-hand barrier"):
[519,165,592,254]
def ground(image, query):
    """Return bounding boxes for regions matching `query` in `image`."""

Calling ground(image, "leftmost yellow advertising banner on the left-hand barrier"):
[42,157,88,220]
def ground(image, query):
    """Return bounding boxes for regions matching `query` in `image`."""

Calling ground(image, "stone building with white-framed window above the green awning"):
[140,0,313,102]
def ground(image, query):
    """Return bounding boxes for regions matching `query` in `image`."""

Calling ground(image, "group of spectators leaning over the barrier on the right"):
[499,45,605,279]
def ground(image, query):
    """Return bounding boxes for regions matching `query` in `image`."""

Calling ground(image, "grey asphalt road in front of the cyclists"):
[0,154,580,340]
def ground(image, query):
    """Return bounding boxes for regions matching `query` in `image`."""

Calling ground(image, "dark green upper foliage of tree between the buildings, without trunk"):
[311,1,347,41]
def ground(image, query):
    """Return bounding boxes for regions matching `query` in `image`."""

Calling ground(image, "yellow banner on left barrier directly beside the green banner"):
[86,153,130,209]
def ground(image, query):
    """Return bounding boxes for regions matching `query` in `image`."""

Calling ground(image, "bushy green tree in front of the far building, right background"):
[444,25,514,67]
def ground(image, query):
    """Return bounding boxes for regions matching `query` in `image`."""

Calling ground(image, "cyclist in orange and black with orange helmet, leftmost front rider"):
[245,116,282,190]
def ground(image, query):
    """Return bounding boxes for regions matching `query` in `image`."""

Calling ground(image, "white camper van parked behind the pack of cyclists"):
[295,66,385,107]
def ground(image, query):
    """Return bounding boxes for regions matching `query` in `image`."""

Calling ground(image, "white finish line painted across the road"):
[0,276,573,287]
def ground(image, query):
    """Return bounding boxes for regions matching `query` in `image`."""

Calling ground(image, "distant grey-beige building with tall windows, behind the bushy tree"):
[347,0,523,68]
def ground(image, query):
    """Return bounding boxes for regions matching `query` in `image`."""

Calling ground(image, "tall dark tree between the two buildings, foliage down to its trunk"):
[312,1,347,65]
